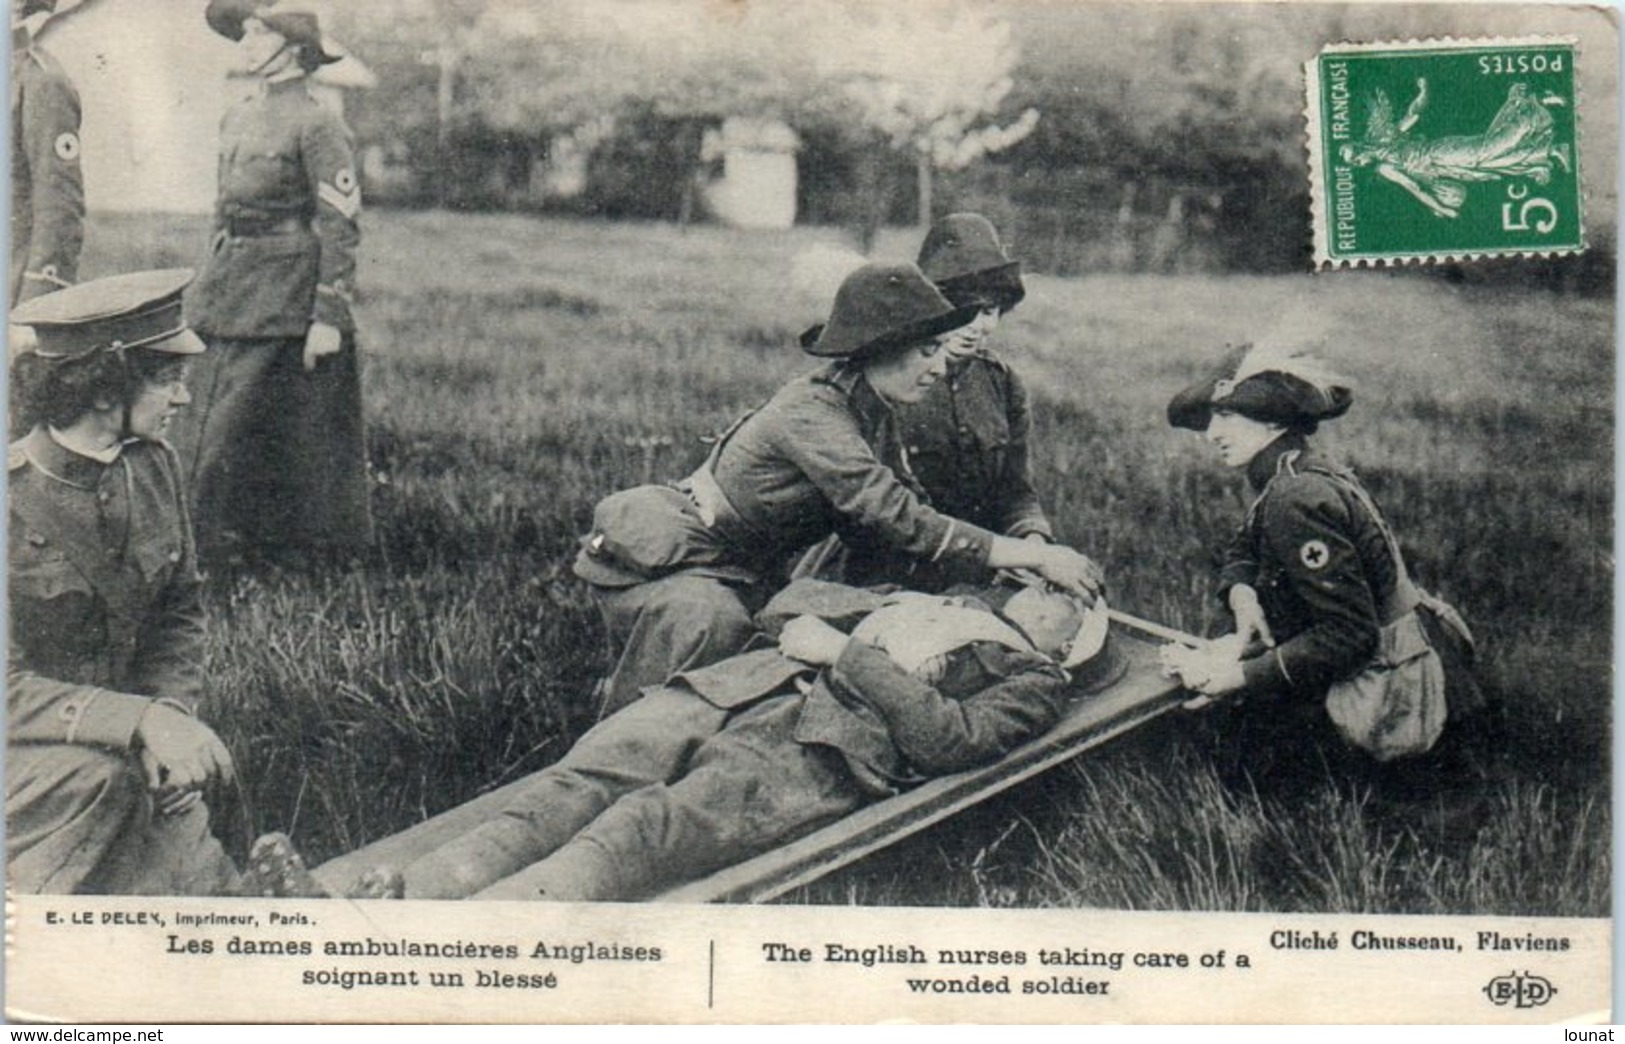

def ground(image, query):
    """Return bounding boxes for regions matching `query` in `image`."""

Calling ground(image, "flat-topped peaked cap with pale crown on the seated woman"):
[11,268,203,363]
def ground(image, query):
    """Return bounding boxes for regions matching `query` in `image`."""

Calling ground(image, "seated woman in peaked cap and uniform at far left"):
[5,270,308,894]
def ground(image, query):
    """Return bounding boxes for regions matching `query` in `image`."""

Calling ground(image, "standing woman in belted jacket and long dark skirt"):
[177,0,372,561]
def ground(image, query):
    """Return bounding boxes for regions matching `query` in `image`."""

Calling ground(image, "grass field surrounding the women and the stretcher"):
[85,213,1614,914]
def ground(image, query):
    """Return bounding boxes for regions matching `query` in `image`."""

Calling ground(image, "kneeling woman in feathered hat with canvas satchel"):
[1164,348,1484,781]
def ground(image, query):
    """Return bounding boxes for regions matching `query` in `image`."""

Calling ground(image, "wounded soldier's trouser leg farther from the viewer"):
[403,686,728,899]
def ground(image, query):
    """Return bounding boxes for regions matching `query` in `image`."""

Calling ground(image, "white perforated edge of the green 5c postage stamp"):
[1303,34,1589,272]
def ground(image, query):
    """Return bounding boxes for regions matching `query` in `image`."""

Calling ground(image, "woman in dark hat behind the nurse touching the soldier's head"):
[798,213,1055,590]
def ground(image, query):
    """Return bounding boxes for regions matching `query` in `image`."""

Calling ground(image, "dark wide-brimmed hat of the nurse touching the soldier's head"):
[801,262,977,359]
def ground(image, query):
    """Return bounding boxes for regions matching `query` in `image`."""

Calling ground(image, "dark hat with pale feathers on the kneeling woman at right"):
[1168,345,1354,431]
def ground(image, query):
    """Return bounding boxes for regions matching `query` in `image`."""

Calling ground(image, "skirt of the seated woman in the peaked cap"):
[5,743,239,896]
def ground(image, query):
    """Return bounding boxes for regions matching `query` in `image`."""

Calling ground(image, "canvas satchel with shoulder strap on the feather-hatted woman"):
[1316,468,1461,761]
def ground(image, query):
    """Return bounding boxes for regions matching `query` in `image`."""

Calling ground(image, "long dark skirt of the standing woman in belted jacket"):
[174,333,372,563]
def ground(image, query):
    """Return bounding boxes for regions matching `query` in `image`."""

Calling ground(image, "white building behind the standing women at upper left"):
[39,0,375,213]
